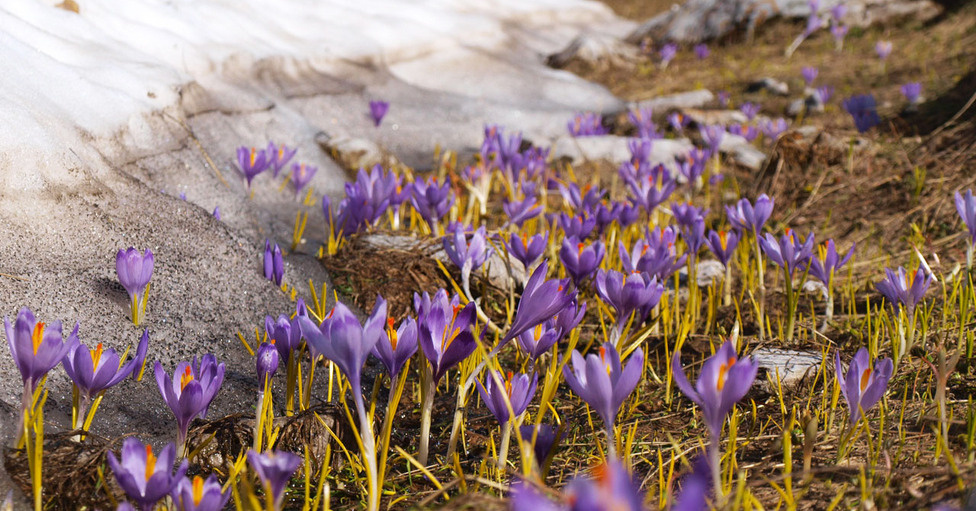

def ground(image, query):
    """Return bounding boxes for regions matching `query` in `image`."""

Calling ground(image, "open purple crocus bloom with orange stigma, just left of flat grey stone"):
[671,341,759,439]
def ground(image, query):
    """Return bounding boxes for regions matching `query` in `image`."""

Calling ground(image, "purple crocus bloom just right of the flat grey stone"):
[834,348,894,425]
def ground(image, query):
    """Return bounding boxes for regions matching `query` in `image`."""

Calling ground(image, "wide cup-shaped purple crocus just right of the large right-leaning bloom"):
[596,270,664,332]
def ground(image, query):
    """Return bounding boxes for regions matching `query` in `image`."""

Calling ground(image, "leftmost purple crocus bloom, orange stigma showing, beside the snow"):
[3,307,72,392]
